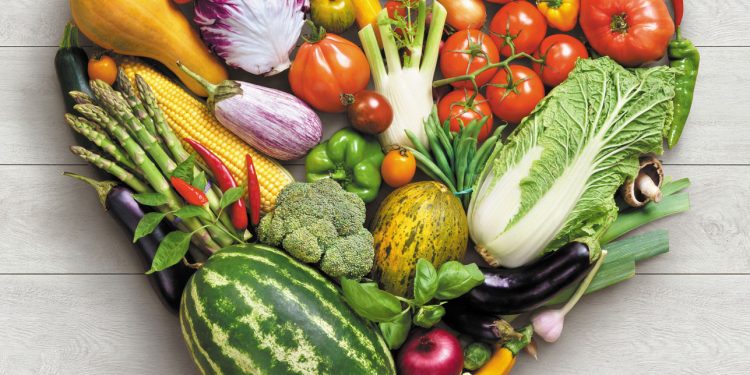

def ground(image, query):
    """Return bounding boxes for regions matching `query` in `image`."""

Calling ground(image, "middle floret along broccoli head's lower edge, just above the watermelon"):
[283,220,338,263]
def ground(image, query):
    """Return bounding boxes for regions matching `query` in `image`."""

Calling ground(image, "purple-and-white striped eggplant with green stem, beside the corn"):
[177,63,323,160]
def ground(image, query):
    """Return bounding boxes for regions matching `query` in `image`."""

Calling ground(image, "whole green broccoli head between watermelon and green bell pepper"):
[258,178,375,278]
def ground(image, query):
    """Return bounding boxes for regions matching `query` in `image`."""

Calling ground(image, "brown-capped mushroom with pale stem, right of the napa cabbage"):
[621,155,664,207]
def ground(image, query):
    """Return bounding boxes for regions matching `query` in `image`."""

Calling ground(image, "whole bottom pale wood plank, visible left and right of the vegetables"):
[0,275,750,375]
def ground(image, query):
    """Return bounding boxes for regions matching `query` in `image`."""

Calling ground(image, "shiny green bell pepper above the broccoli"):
[305,128,384,203]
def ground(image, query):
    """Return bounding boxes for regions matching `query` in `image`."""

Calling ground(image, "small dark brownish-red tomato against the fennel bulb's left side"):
[344,90,393,134]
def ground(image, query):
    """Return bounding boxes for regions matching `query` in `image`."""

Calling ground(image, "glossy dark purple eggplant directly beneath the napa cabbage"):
[458,242,591,315]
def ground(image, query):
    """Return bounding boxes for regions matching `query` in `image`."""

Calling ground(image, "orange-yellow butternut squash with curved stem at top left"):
[70,0,227,96]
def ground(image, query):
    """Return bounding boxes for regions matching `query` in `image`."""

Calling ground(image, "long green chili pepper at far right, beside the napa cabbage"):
[666,27,701,148]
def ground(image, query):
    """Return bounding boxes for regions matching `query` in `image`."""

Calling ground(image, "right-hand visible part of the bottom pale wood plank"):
[513,275,750,375]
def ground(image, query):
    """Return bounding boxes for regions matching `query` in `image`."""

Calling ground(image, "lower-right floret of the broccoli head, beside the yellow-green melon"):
[320,228,375,279]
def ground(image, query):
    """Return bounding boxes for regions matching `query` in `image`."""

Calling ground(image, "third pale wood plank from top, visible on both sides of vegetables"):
[0,166,750,273]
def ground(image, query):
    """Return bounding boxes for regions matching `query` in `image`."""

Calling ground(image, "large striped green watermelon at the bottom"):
[180,244,396,375]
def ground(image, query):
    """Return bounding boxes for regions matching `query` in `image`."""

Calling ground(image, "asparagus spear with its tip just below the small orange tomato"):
[91,80,177,175]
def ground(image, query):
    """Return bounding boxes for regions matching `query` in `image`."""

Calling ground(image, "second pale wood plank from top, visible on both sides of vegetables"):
[0,48,750,164]
